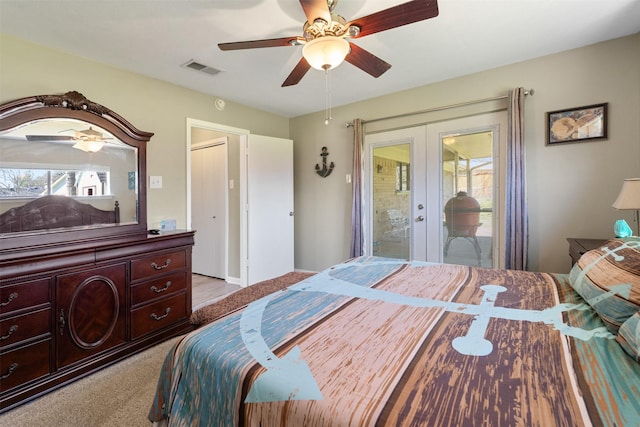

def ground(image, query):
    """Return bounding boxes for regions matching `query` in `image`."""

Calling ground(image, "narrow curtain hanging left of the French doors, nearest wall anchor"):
[351,119,364,258]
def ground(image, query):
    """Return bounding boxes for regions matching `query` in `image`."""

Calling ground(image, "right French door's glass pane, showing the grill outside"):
[442,131,494,268]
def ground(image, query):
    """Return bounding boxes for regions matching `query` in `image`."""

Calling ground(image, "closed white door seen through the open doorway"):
[191,137,227,279]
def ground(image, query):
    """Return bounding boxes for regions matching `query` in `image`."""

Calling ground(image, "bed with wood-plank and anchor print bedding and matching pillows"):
[149,238,640,426]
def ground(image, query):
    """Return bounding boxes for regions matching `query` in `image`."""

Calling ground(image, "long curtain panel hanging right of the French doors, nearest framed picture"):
[505,87,529,270]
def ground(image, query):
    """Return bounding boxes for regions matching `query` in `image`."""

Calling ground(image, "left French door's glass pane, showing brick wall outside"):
[372,144,411,259]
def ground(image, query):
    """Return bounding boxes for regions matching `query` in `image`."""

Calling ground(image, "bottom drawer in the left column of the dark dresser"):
[0,340,51,392]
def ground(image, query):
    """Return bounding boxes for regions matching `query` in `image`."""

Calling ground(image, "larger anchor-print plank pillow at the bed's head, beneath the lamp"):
[569,237,640,334]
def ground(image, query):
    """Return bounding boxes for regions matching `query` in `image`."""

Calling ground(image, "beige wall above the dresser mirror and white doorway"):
[0,34,289,236]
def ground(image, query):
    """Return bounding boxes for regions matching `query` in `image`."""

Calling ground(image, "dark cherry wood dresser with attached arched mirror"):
[0,91,194,412]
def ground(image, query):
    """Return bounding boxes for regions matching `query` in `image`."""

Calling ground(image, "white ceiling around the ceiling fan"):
[0,0,640,117]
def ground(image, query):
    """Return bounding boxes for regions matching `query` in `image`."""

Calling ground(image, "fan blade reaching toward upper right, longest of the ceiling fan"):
[349,0,439,37]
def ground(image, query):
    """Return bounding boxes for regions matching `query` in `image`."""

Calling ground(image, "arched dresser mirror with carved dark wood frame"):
[0,92,153,248]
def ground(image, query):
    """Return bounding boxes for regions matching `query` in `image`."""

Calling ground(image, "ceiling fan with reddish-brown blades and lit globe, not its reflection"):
[218,0,438,87]
